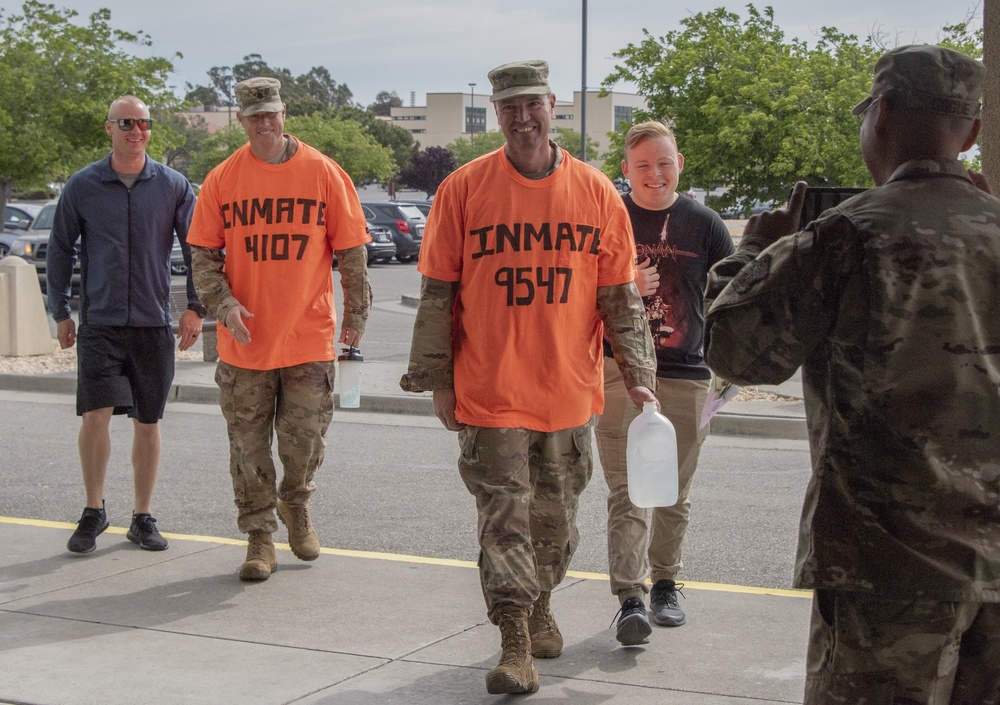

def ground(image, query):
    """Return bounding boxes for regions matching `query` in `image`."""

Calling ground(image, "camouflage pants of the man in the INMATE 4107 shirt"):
[215,361,335,533]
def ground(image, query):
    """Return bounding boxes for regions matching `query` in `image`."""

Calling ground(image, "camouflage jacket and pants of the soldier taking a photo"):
[706,158,1000,703]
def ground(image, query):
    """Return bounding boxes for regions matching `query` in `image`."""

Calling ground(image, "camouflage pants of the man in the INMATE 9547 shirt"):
[458,422,594,624]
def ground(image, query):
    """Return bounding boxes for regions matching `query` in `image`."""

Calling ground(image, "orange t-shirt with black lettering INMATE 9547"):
[418,148,635,431]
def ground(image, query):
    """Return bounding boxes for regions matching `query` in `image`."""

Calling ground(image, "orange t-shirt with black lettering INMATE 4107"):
[188,141,370,370]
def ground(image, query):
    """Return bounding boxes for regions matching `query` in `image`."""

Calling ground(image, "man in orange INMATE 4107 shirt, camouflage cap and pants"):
[188,78,371,580]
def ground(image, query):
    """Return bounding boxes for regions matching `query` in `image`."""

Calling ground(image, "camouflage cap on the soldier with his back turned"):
[851,44,986,118]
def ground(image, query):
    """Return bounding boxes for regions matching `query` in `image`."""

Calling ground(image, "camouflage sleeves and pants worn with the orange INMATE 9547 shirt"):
[400,258,656,624]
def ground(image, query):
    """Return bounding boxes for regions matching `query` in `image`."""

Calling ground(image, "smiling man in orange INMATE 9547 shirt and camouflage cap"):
[400,61,656,693]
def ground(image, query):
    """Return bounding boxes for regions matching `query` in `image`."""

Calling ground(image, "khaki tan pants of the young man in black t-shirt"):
[596,357,711,602]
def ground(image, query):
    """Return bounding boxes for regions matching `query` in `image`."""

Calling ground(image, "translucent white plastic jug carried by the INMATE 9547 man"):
[625,401,677,507]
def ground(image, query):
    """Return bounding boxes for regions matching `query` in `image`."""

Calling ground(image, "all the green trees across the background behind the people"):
[0,0,983,213]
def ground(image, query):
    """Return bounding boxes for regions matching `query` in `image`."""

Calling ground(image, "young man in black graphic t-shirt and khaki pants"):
[596,121,734,646]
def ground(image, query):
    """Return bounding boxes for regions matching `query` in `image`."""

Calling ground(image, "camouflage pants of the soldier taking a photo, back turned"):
[804,590,1000,705]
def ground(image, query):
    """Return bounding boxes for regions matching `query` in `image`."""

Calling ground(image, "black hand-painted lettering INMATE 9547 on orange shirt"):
[469,217,601,306]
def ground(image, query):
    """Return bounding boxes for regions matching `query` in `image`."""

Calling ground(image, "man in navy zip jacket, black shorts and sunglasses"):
[46,96,205,553]
